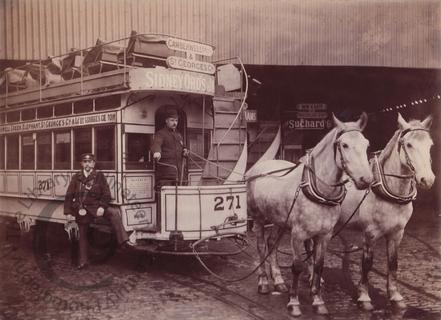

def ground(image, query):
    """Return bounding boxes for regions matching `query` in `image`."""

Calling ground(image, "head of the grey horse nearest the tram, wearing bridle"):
[332,112,373,189]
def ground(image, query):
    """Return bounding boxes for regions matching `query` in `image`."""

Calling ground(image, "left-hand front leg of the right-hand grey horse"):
[357,234,374,311]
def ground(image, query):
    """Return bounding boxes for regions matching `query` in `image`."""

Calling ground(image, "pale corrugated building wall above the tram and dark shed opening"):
[0,0,441,68]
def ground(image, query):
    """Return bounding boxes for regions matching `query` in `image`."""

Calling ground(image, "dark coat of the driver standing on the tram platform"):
[151,127,185,185]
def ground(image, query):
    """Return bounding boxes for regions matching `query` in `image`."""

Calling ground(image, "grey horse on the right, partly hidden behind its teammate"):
[340,114,435,310]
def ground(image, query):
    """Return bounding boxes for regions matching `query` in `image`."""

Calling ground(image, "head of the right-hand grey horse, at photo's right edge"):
[398,113,435,189]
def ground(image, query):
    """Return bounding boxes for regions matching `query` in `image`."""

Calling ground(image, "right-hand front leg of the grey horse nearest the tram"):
[311,233,332,314]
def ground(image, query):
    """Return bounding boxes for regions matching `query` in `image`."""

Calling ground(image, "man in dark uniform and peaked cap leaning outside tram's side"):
[64,153,134,269]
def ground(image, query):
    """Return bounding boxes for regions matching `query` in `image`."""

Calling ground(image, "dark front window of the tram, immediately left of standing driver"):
[126,133,153,170]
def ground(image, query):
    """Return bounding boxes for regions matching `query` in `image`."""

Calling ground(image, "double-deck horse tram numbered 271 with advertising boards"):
[0,32,251,254]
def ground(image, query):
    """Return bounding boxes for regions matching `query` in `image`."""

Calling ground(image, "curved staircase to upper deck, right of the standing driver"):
[201,97,247,184]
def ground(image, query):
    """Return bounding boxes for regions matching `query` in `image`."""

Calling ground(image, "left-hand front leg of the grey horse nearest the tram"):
[287,239,306,317]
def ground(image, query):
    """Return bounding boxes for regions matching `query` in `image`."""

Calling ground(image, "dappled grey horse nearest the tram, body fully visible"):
[247,113,372,316]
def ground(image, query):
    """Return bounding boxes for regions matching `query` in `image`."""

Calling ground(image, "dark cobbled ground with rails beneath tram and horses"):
[0,201,441,320]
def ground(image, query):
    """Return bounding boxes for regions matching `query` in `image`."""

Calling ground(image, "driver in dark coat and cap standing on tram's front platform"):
[151,109,189,191]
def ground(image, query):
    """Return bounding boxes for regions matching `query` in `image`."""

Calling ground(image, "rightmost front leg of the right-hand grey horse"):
[386,230,406,309]
